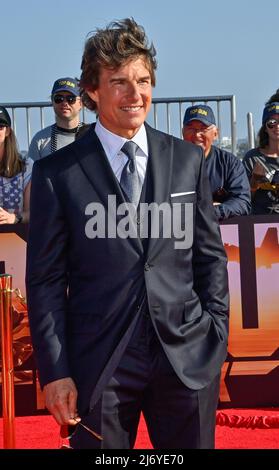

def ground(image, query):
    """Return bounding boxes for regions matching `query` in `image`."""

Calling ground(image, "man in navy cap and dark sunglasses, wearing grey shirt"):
[28,77,87,161]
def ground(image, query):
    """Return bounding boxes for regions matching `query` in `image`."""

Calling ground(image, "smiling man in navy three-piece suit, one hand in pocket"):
[27,19,231,449]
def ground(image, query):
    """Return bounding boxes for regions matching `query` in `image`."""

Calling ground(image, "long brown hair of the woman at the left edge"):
[0,127,25,178]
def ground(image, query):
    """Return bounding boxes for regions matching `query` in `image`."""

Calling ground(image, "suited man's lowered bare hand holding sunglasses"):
[44,377,80,426]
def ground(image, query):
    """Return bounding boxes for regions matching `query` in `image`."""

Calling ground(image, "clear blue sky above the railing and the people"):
[0,0,279,147]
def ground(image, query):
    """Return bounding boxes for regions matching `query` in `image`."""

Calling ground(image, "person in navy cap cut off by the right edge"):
[243,102,279,214]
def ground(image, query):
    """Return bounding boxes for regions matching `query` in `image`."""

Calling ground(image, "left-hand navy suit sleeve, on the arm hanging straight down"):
[26,161,70,386]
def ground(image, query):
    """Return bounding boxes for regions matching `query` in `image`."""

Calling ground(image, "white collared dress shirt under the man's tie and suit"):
[95,119,148,184]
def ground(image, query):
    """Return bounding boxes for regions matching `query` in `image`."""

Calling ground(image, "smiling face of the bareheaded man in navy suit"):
[86,57,152,139]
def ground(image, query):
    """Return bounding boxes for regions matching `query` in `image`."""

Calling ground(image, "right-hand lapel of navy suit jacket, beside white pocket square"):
[145,124,173,256]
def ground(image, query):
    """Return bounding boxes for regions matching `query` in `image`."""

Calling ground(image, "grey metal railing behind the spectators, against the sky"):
[0,95,237,153]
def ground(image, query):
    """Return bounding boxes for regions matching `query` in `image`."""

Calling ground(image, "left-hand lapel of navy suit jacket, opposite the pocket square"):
[75,126,143,254]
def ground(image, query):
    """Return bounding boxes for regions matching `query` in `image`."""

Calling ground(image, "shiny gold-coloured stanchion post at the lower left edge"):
[0,274,15,449]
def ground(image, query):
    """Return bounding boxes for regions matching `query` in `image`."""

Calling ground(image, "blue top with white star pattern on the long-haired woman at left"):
[0,158,33,213]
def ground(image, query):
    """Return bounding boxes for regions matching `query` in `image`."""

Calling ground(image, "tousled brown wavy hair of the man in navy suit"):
[80,18,157,111]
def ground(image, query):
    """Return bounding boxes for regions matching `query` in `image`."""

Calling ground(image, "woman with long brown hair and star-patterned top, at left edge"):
[0,106,33,224]
